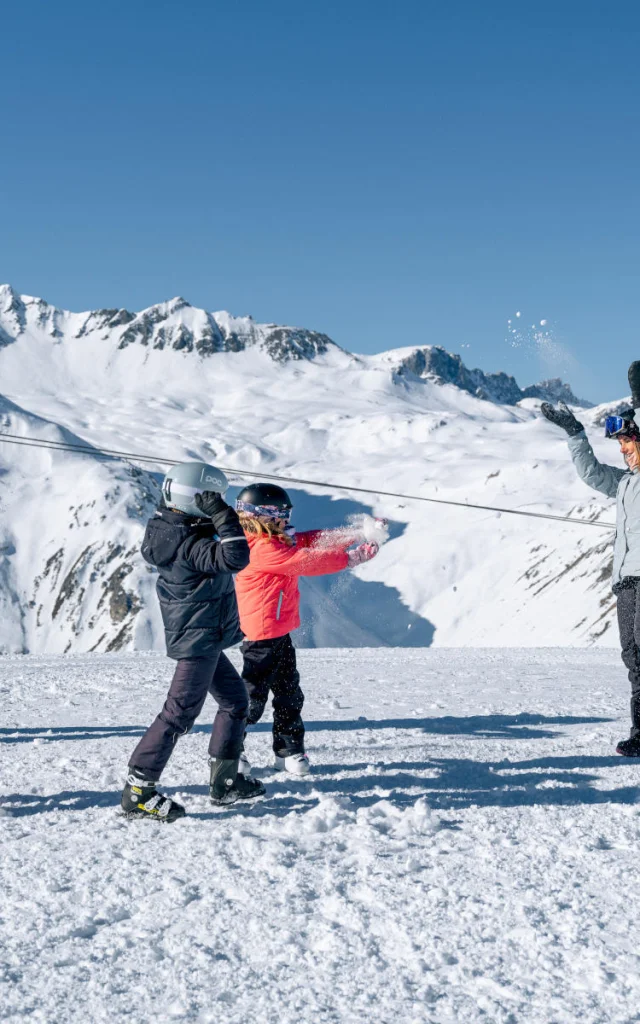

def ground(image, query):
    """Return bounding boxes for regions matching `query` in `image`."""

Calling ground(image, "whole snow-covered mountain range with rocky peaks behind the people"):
[0,286,620,651]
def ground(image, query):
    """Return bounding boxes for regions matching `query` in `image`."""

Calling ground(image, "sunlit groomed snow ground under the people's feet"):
[0,648,640,1024]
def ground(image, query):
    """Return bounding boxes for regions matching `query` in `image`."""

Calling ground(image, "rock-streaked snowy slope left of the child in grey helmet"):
[0,387,159,653]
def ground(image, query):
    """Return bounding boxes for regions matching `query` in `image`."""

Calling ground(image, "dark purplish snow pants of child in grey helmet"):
[129,653,248,781]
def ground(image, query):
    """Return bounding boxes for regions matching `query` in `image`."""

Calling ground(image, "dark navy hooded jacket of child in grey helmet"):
[142,506,250,659]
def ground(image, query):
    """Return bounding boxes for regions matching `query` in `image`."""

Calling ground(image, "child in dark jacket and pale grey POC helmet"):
[122,463,264,821]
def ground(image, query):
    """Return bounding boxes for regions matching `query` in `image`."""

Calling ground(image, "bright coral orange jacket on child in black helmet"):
[236,529,351,640]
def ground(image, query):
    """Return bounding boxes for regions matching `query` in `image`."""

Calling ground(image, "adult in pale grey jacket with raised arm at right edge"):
[541,360,640,758]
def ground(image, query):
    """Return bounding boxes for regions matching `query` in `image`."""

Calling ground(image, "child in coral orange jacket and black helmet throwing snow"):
[236,483,378,775]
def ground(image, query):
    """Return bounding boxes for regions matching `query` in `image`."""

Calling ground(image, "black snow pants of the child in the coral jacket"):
[242,633,304,754]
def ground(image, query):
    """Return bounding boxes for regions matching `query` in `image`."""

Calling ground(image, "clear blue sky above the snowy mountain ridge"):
[0,0,640,400]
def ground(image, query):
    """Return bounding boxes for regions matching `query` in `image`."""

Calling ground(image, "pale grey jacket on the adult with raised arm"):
[568,430,640,587]
